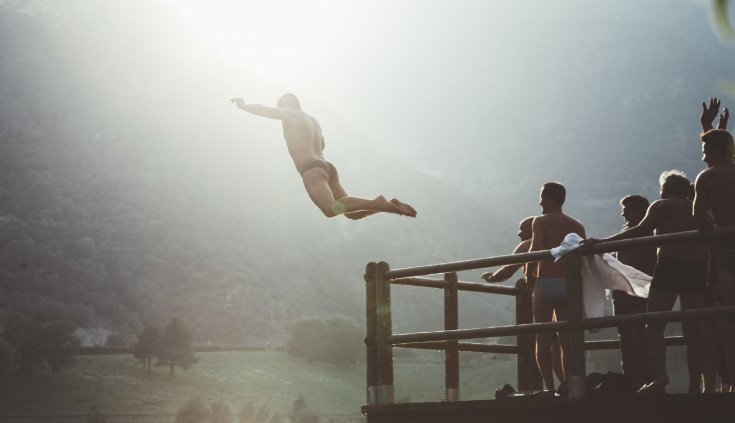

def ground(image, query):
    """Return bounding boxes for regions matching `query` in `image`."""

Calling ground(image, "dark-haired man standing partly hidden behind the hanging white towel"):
[612,195,656,388]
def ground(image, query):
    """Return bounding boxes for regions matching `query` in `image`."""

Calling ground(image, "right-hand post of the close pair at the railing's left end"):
[375,261,394,404]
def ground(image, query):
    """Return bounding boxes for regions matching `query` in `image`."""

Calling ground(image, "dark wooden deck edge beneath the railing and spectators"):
[362,394,735,423]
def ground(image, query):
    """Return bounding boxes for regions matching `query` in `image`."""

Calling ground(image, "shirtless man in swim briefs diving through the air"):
[230,93,416,220]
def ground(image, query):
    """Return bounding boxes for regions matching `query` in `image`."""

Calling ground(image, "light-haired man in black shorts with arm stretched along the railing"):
[585,170,708,394]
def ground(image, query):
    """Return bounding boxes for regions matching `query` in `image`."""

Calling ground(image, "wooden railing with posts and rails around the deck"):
[365,227,735,404]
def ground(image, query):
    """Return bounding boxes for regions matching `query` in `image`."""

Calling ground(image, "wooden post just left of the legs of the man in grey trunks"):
[515,279,541,393]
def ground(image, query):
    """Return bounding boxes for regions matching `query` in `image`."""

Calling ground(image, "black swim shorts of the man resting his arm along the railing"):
[651,257,707,294]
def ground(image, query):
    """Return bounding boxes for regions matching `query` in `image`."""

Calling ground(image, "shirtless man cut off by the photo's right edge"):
[694,129,735,390]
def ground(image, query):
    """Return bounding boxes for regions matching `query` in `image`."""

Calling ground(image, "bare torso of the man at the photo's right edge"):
[697,164,735,227]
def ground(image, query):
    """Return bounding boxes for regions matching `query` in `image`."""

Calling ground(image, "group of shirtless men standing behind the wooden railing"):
[482,98,735,395]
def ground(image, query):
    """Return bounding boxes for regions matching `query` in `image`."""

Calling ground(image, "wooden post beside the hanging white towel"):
[564,253,587,398]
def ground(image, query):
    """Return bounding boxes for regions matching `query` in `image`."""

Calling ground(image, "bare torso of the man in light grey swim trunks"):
[533,213,586,278]
